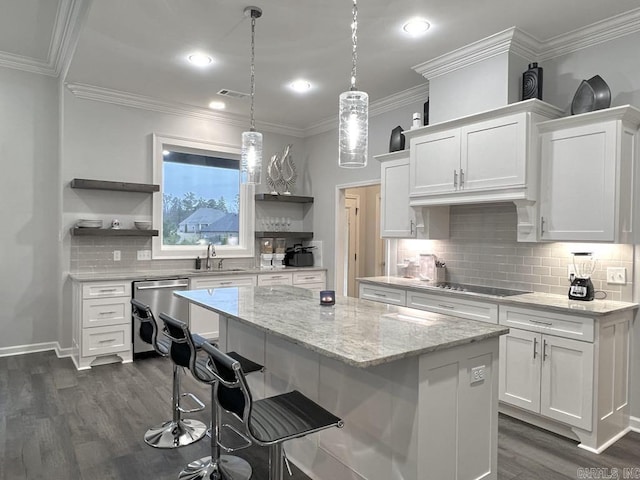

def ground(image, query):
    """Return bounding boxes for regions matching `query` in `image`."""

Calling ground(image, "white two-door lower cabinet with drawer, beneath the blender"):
[499,305,633,453]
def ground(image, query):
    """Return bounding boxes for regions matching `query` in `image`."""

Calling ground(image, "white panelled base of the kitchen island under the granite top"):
[219,316,499,480]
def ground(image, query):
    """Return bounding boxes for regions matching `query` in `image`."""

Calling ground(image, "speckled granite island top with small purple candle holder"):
[174,286,509,368]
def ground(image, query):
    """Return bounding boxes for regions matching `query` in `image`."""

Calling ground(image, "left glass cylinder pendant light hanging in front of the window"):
[240,7,262,183]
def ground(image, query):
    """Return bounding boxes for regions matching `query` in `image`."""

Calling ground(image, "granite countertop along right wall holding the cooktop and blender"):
[358,276,638,317]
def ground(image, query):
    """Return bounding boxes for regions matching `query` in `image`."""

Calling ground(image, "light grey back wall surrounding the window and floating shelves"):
[60,91,307,347]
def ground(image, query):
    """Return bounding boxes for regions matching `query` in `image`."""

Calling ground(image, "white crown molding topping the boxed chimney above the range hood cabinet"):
[412,27,540,79]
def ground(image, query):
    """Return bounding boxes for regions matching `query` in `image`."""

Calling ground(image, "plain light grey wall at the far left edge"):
[0,68,60,353]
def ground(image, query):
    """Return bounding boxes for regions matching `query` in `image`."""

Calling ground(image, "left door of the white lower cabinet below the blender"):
[499,328,542,413]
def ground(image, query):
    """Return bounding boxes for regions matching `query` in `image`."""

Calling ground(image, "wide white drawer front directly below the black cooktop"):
[407,292,498,323]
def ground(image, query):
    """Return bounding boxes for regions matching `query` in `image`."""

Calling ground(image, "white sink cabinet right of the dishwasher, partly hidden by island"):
[189,275,256,340]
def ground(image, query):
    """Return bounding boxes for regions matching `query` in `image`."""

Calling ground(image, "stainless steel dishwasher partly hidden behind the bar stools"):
[131,278,189,357]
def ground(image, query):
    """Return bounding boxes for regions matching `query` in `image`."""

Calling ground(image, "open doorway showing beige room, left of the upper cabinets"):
[335,183,386,297]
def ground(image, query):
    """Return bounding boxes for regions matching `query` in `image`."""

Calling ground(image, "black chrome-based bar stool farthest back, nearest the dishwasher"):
[131,298,207,448]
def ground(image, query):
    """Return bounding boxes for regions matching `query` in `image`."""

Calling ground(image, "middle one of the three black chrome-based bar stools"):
[160,313,263,480]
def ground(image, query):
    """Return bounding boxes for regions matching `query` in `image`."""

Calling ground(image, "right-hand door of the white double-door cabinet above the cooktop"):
[459,113,527,190]
